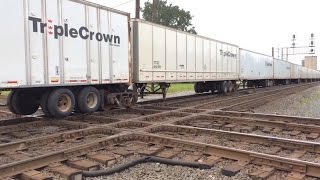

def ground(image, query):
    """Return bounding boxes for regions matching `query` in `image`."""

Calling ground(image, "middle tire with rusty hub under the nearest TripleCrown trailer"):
[47,88,75,118]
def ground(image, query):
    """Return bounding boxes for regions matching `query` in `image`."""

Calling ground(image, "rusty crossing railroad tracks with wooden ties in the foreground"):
[0,84,320,179]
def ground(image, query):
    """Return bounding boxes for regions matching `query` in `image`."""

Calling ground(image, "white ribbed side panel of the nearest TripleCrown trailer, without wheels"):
[0,0,129,88]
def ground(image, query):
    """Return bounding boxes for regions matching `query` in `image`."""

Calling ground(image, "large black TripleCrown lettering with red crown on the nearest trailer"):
[29,16,120,46]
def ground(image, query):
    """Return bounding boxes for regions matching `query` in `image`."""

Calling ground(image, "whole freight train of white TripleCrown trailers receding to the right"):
[0,0,320,118]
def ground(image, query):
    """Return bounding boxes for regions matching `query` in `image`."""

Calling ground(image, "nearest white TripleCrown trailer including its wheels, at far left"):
[0,0,135,117]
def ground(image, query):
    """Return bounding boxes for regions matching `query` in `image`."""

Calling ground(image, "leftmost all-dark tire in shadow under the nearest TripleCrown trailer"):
[10,90,39,115]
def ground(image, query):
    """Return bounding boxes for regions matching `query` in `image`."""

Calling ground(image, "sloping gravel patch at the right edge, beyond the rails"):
[254,86,320,118]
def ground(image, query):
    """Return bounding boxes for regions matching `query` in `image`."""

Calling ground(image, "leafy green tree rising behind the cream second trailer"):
[142,0,197,34]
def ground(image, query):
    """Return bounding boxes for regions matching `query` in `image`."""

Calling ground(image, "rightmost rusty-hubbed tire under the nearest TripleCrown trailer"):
[77,87,101,113]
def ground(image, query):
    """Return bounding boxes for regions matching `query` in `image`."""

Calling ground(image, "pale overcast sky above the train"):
[89,0,320,69]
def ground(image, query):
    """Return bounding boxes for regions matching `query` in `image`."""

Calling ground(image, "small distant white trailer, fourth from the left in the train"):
[273,58,291,85]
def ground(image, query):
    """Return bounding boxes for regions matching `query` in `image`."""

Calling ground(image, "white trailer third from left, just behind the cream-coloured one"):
[240,48,273,87]
